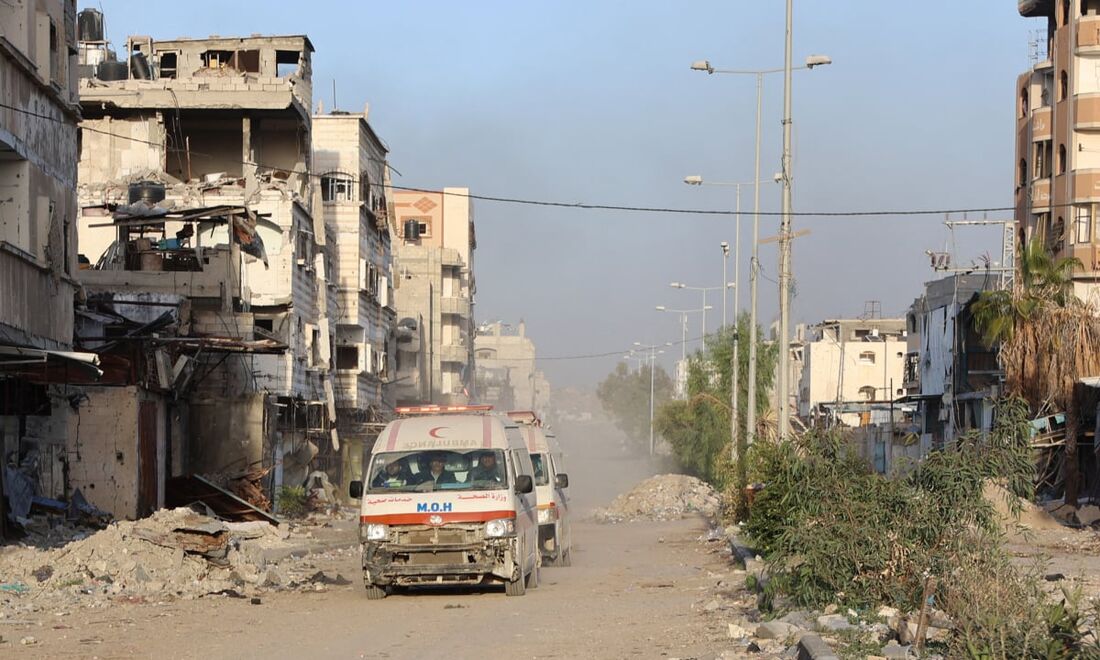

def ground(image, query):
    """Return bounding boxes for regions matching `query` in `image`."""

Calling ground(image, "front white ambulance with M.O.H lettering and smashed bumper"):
[351,406,541,600]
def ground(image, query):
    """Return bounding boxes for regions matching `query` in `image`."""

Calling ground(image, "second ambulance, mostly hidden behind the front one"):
[508,410,573,567]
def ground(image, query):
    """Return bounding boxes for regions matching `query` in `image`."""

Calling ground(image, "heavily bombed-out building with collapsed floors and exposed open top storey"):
[73,30,339,492]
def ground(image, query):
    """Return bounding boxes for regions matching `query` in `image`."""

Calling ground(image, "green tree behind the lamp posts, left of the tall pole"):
[655,314,778,491]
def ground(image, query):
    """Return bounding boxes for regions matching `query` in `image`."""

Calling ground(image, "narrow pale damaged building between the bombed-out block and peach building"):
[314,109,396,481]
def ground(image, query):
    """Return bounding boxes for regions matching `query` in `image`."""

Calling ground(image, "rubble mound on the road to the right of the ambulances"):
[593,474,722,523]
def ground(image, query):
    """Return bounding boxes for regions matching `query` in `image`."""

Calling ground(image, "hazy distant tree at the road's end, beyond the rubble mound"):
[596,362,672,449]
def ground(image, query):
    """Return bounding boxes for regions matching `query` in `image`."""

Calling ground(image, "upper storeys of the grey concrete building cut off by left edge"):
[0,0,79,349]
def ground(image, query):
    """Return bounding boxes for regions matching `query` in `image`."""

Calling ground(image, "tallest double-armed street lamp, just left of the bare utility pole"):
[691,51,833,442]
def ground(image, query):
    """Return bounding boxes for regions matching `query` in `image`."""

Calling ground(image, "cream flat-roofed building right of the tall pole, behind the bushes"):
[796,319,906,426]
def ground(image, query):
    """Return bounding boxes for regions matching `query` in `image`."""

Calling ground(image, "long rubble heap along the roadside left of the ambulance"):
[0,508,340,605]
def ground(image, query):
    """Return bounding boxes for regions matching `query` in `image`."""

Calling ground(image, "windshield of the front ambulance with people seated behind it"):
[370,449,508,493]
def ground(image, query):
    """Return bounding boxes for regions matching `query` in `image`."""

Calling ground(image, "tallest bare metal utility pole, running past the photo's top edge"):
[776,0,794,439]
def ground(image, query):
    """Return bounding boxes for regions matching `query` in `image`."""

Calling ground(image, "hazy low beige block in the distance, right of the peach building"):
[474,321,550,419]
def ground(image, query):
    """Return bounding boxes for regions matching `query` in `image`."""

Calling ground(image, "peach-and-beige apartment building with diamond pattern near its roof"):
[393,188,477,404]
